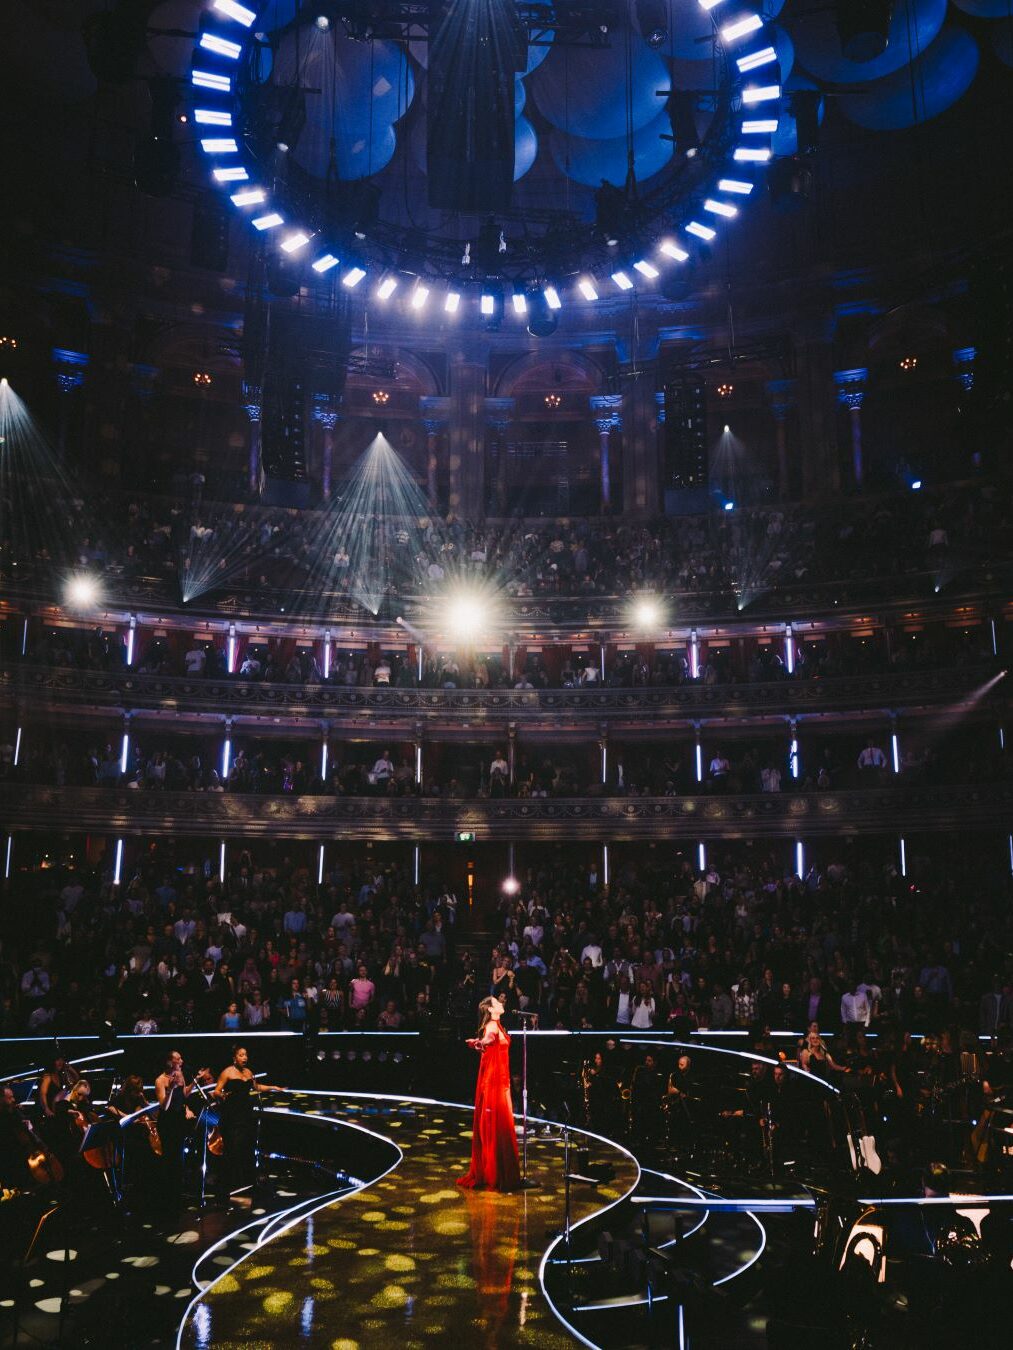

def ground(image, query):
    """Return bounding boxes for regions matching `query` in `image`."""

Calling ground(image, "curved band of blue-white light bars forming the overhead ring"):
[190,0,783,323]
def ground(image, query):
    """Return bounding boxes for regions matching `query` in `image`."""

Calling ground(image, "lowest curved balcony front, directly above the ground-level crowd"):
[0,783,1013,842]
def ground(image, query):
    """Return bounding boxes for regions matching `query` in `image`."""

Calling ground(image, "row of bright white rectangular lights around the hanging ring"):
[192,0,782,321]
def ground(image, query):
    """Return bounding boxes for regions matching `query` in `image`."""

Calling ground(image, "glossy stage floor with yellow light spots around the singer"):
[180,1098,638,1350]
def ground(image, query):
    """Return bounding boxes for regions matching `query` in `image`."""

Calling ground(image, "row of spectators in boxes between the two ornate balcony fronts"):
[0,716,1009,801]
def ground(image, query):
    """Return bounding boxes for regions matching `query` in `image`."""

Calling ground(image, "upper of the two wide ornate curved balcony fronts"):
[0,664,995,730]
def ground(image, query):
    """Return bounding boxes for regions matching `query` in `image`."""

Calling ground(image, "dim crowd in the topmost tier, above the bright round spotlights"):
[0,469,1013,614]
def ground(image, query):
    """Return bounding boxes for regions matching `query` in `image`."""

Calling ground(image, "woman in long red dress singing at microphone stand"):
[458,996,520,1191]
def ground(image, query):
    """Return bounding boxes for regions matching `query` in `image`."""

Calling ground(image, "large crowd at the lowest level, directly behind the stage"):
[0,841,1013,1057]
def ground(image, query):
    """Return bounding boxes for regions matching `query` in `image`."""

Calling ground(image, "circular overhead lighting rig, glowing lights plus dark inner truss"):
[190,0,785,323]
